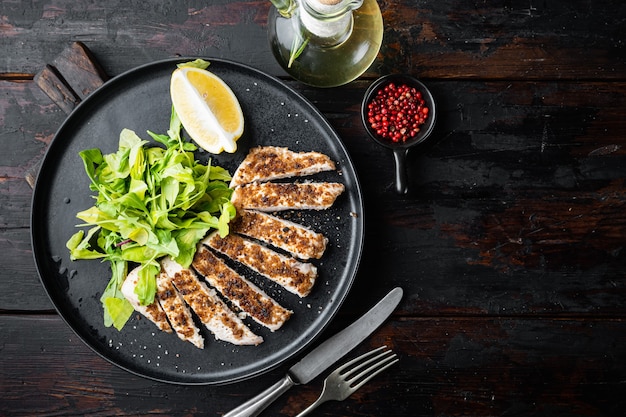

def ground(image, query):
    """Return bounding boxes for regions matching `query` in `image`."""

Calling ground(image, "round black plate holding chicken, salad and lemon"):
[31,58,363,384]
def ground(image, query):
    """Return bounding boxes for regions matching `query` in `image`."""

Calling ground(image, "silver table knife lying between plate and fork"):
[223,287,403,417]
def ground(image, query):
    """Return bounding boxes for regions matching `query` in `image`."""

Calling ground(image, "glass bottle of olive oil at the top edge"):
[268,0,383,87]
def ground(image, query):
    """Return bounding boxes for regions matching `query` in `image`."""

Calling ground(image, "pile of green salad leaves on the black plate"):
[66,108,236,330]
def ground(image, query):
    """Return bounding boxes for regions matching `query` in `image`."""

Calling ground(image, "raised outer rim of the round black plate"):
[30,57,365,386]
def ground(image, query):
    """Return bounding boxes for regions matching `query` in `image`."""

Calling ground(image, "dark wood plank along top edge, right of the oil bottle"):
[382,1,626,79]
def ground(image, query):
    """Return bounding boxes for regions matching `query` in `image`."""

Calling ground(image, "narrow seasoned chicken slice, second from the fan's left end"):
[157,270,204,349]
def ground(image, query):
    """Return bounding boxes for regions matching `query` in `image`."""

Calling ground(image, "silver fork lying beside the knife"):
[296,346,399,417]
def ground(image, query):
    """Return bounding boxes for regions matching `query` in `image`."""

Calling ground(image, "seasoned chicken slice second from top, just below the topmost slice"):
[231,182,345,212]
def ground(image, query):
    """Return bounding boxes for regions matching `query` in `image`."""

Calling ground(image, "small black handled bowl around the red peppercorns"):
[361,74,437,194]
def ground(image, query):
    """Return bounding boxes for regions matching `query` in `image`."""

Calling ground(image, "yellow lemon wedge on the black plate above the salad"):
[170,67,244,154]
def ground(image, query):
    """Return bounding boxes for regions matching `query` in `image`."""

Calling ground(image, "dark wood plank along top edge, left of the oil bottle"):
[0,0,280,74]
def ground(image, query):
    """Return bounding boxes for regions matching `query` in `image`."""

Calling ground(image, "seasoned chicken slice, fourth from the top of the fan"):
[202,233,317,297]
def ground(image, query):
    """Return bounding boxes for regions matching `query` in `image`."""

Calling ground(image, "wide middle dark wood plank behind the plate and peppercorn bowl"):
[0,81,626,316]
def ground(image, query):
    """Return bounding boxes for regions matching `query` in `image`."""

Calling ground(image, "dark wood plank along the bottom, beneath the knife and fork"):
[0,315,626,417]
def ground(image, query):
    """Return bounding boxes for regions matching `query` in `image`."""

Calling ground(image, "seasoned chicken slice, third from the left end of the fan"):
[161,256,263,345]
